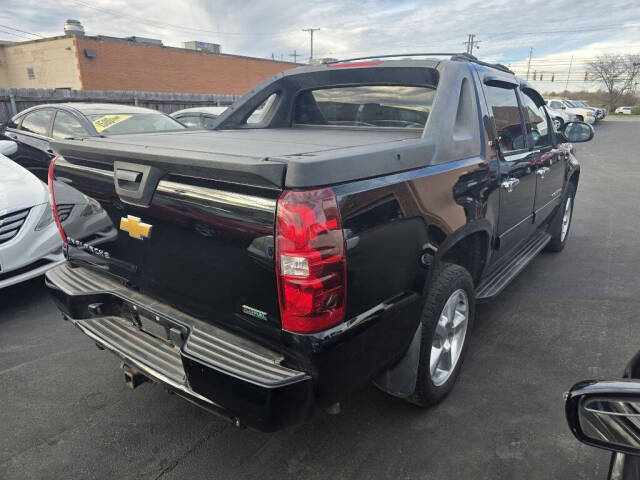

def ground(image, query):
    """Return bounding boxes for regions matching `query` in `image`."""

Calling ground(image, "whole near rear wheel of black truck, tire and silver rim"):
[408,263,475,407]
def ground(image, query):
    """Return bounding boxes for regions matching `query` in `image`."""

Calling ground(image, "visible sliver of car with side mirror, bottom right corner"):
[565,352,640,480]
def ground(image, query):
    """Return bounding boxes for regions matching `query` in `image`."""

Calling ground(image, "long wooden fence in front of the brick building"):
[0,88,240,123]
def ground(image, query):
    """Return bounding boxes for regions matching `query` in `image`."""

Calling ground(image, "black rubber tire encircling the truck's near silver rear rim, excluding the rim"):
[407,263,475,407]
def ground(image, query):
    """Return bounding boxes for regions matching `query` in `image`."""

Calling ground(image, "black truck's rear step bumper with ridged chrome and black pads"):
[46,263,314,431]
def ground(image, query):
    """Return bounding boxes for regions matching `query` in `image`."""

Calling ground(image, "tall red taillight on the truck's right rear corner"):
[276,189,347,333]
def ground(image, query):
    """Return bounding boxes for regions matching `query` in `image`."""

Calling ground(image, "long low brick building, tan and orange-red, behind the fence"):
[0,24,297,94]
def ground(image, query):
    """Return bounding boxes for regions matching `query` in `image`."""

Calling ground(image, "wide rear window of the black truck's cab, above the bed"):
[294,85,435,128]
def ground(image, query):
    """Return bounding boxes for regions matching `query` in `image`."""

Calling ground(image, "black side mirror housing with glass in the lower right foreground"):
[565,379,640,455]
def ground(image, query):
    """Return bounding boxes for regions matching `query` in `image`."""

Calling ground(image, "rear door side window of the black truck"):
[485,86,526,153]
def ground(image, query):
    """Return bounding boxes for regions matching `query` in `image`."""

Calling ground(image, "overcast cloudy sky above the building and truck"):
[0,0,640,91]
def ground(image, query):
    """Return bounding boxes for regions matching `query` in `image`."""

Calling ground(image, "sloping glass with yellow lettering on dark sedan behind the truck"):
[87,113,186,135]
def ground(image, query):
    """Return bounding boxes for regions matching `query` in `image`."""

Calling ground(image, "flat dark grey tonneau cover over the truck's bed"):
[52,127,430,188]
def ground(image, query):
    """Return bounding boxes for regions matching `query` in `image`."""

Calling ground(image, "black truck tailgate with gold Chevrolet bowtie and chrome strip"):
[53,140,284,331]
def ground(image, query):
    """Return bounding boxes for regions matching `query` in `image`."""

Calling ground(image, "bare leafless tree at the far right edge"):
[587,54,640,112]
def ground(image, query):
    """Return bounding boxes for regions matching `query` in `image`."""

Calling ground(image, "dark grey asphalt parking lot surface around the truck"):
[0,119,640,480]
